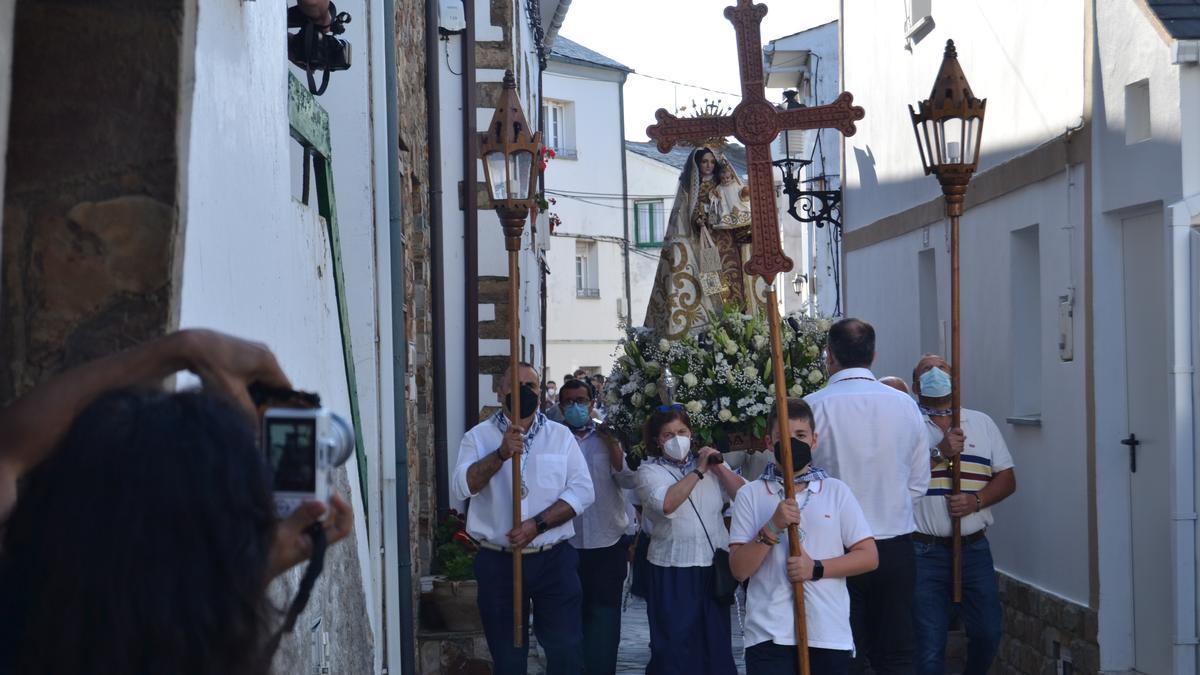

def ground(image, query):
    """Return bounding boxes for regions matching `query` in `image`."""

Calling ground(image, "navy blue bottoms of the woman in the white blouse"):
[646,563,737,675]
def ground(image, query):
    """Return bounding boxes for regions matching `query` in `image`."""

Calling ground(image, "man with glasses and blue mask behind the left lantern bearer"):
[558,380,637,673]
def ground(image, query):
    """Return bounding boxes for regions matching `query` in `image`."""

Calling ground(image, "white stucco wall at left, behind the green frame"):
[179,0,392,664]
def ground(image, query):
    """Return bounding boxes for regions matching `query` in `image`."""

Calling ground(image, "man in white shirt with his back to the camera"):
[805,318,929,675]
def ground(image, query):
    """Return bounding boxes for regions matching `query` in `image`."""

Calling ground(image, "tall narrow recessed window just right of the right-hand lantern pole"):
[1009,225,1042,419]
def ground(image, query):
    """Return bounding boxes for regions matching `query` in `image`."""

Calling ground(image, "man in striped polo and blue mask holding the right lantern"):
[912,354,1016,675]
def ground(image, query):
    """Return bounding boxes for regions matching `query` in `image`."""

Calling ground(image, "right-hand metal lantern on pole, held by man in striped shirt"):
[908,40,988,602]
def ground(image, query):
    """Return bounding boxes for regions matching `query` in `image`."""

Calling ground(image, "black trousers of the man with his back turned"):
[846,534,917,675]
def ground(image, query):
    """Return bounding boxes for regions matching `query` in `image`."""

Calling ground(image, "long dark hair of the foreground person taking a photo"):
[0,390,275,675]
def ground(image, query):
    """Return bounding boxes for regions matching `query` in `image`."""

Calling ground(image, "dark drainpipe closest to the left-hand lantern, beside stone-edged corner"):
[463,0,479,422]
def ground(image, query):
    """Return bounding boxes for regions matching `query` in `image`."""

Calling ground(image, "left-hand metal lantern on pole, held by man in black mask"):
[479,70,541,646]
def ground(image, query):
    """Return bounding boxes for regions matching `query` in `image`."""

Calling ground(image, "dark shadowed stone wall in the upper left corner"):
[0,0,182,400]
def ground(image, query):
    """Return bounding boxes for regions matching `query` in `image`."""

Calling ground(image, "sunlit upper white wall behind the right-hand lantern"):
[842,0,1085,230]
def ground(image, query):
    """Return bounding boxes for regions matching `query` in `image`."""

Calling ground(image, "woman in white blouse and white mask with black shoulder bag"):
[637,405,744,675]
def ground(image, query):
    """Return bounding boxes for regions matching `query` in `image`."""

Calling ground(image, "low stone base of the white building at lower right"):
[992,573,1100,675]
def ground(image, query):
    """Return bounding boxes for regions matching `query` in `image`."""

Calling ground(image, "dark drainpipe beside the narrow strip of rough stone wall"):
[429,2,450,521]
